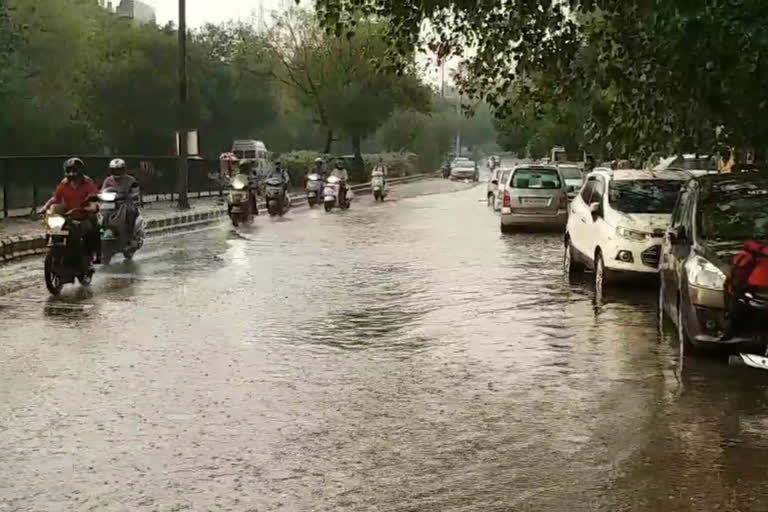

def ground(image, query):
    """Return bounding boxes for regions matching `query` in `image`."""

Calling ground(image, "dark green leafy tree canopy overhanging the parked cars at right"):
[317,0,768,159]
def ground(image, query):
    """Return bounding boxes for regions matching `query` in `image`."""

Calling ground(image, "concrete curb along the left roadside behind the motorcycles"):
[0,174,431,263]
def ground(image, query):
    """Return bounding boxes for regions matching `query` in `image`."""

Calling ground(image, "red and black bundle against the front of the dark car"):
[725,240,768,336]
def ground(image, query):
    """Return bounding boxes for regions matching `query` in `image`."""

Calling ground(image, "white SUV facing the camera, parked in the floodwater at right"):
[563,168,691,296]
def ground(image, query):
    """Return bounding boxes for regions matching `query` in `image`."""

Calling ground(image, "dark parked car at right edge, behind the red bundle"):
[659,173,768,355]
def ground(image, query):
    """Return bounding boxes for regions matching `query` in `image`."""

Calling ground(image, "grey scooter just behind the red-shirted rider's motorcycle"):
[99,186,146,265]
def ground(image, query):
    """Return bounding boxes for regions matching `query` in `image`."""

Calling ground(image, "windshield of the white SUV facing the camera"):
[608,180,683,213]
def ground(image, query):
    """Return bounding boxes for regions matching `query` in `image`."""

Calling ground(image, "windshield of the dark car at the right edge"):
[698,181,768,242]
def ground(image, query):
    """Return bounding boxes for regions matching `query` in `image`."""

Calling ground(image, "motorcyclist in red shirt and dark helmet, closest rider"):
[39,158,101,263]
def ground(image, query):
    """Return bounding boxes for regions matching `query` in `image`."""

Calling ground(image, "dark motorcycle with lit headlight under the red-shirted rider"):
[44,207,94,295]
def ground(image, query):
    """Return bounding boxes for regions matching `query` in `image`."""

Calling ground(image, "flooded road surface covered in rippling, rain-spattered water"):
[0,182,768,511]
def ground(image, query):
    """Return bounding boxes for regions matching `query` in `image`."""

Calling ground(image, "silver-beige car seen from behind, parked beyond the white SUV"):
[500,164,568,233]
